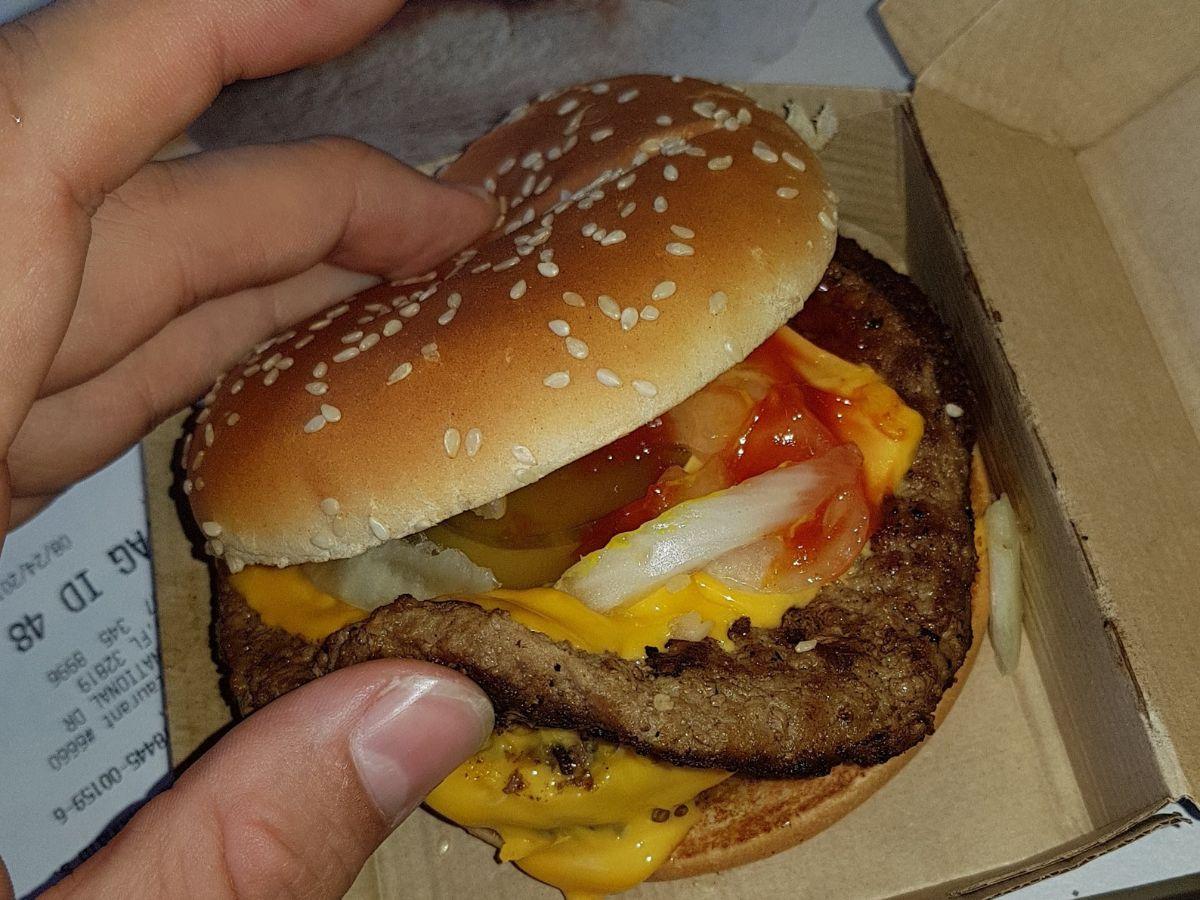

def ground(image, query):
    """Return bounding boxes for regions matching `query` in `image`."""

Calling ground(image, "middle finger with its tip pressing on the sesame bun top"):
[42,138,496,394]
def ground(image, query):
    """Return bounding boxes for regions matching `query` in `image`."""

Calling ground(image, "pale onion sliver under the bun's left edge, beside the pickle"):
[302,538,499,611]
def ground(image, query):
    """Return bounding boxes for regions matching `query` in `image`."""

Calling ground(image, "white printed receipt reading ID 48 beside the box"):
[0,450,168,896]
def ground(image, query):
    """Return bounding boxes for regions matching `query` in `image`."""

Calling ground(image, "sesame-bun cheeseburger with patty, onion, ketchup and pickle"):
[182,76,988,895]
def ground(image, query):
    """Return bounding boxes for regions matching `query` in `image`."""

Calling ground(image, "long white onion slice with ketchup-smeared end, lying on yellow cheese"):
[556,444,862,612]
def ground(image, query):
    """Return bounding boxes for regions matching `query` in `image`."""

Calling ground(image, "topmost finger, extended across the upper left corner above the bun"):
[0,0,402,212]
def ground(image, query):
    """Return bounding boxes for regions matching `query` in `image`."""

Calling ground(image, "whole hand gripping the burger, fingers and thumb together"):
[0,0,494,896]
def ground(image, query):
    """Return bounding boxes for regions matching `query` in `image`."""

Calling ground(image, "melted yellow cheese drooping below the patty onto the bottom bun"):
[428,728,728,900]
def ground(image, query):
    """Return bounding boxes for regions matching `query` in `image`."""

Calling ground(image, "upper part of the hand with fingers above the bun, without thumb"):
[0,0,494,541]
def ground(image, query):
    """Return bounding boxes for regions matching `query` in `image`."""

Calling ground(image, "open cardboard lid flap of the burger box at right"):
[882,0,1200,814]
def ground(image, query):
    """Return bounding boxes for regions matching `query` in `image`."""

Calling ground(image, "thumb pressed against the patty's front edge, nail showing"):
[50,660,492,898]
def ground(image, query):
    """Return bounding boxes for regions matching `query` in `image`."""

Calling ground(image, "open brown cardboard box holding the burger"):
[145,0,1200,898]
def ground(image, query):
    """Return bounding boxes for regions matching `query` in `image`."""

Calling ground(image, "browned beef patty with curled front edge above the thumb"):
[218,239,976,778]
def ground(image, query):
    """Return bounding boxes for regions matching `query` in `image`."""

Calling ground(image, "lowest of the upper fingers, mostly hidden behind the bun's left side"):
[8,265,378,497]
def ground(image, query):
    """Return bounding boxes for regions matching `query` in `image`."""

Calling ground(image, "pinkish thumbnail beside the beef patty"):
[350,674,494,826]
